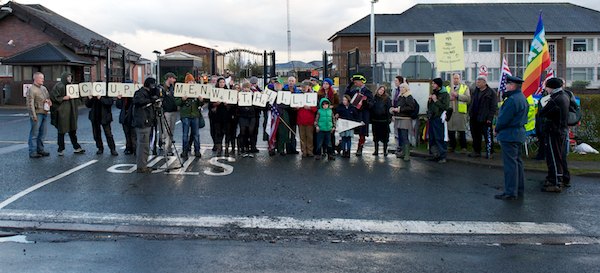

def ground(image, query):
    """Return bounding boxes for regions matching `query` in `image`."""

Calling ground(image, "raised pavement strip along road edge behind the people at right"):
[411,149,600,177]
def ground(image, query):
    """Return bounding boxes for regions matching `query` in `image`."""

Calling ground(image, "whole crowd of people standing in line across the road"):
[27,69,570,200]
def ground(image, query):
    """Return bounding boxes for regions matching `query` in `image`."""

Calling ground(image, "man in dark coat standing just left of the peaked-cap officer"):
[469,76,498,158]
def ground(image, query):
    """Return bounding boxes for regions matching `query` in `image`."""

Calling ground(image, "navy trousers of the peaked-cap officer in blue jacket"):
[500,141,525,196]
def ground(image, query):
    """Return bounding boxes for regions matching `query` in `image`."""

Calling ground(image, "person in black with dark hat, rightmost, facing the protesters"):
[540,78,571,192]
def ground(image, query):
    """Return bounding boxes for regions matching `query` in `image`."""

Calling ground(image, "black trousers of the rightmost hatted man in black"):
[545,132,571,186]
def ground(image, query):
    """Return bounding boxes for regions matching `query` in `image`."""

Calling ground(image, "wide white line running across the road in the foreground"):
[0,210,580,235]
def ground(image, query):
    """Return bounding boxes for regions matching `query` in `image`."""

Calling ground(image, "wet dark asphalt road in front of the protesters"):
[0,106,600,272]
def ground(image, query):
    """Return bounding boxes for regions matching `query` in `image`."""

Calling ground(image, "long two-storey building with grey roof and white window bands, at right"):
[329,3,600,87]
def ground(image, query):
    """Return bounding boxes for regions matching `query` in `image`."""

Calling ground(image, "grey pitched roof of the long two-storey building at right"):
[329,3,600,40]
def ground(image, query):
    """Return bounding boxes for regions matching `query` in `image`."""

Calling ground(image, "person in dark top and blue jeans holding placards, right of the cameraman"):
[175,73,204,159]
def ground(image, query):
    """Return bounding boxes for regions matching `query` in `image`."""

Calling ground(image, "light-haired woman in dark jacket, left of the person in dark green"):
[389,83,419,161]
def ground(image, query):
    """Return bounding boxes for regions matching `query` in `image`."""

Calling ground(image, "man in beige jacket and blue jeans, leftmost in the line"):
[27,72,52,158]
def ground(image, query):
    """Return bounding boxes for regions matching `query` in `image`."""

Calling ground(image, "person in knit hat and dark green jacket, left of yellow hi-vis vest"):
[427,78,450,163]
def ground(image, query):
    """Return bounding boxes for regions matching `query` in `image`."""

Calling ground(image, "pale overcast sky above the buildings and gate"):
[0,0,599,63]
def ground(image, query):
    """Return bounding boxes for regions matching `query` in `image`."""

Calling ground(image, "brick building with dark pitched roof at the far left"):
[0,1,142,104]
